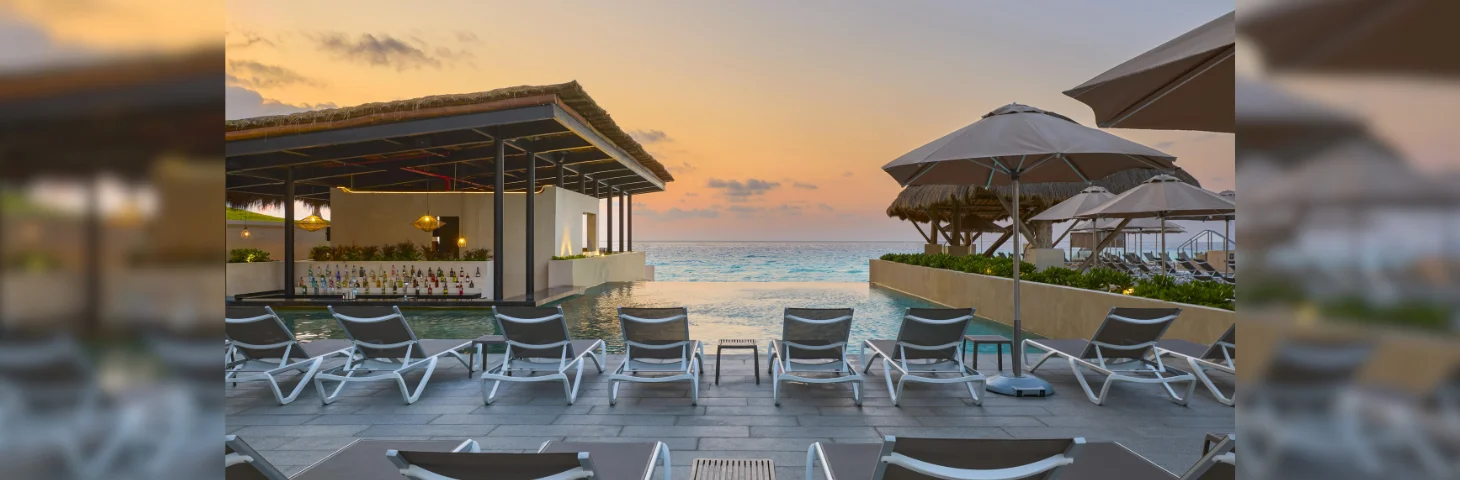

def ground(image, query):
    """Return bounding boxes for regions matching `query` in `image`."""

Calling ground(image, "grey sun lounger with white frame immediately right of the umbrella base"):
[1018,308,1196,406]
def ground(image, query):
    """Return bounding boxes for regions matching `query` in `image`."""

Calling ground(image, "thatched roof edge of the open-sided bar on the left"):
[223,80,675,182]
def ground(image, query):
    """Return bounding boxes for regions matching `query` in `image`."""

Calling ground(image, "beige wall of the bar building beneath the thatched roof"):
[330,187,599,298]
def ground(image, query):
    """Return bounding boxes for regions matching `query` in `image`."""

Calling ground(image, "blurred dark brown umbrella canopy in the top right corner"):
[1237,0,1460,77]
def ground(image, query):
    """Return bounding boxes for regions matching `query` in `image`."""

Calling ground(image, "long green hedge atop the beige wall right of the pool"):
[882,254,1237,309]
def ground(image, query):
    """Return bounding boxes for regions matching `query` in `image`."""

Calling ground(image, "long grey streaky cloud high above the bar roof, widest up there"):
[312,34,475,71]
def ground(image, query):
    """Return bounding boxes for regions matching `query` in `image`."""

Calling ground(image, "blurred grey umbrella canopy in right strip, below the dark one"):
[1235,77,1365,152]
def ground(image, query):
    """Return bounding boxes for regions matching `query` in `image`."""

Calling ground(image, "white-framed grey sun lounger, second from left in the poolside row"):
[314,306,472,404]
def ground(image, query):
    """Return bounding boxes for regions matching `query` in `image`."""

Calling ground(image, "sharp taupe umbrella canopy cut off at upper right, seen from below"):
[1064,12,1237,133]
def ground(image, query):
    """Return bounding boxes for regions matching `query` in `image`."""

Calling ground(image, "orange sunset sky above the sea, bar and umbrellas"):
[226,1,1234,239]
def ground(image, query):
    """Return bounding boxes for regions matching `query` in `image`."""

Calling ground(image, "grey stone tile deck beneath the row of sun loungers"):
[225,352,1235,479]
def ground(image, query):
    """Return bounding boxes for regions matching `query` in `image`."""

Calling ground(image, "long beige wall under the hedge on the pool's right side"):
[869,260,1237,343]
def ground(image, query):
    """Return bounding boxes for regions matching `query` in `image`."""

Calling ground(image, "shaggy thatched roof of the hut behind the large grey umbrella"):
[886,168,1200,222]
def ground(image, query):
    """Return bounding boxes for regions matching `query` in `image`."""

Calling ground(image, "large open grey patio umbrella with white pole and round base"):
[882,104,1175,395]
